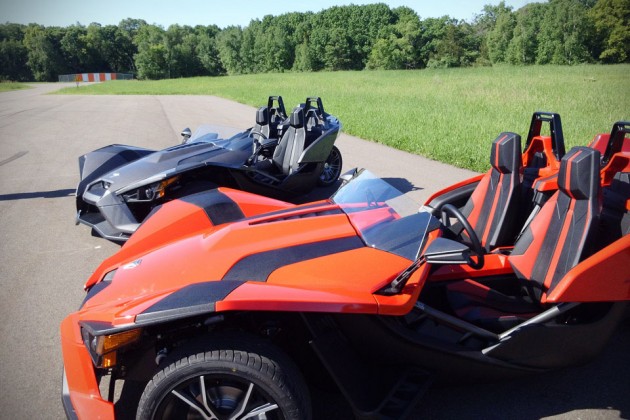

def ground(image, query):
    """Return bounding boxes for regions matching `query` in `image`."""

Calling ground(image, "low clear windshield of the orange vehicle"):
[331,170,439,260]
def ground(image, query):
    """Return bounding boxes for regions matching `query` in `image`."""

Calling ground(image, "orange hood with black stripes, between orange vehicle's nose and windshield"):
[80,202,422,326]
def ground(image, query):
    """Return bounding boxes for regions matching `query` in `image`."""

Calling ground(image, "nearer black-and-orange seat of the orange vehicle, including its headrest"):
[509,147,600,303]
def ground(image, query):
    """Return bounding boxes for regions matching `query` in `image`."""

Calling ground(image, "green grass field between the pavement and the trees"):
[56,65,630,171]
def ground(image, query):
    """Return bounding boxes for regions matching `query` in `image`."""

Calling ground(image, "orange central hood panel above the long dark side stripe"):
[85,214,356,316]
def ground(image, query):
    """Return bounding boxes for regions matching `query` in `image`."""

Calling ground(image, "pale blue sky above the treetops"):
[0,0,532,28]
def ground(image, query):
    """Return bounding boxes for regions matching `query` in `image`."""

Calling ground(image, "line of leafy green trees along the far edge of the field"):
[0,0,630,81]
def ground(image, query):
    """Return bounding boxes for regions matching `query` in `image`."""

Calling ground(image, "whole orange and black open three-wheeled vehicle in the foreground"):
[61,113,630,419]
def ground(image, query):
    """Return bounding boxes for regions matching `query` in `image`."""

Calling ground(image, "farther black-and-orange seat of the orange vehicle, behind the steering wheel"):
[462,133,522,251]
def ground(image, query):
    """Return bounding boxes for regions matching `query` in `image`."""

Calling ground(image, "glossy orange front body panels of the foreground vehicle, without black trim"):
[61,190,438,418]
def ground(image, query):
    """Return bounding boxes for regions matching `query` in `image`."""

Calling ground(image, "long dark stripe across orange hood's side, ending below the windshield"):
[223,236,365,282]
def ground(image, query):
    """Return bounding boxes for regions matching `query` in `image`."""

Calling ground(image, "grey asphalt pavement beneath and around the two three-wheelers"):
[0,84,630,419]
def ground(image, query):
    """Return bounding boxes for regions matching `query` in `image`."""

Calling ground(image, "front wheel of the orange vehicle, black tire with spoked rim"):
[136,336,311,420]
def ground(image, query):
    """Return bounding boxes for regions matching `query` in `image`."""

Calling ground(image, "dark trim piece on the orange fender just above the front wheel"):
[136,281,244,325]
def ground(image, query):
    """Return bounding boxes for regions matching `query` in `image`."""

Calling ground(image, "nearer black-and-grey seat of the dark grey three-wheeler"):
[273,107,306,175]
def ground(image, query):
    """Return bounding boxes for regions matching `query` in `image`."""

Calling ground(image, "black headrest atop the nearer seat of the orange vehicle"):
[558,146,600,199]
